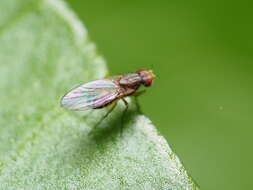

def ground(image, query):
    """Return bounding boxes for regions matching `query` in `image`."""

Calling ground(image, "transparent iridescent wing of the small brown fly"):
[61,79,118,110]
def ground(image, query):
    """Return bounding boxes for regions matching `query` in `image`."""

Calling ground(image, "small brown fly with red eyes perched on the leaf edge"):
[61,69,155,127]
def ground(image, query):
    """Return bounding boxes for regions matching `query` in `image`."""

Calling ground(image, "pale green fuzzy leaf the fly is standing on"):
[0,0,198,190]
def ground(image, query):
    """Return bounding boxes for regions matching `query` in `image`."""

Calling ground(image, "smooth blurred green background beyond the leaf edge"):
[67,0,253,190]
